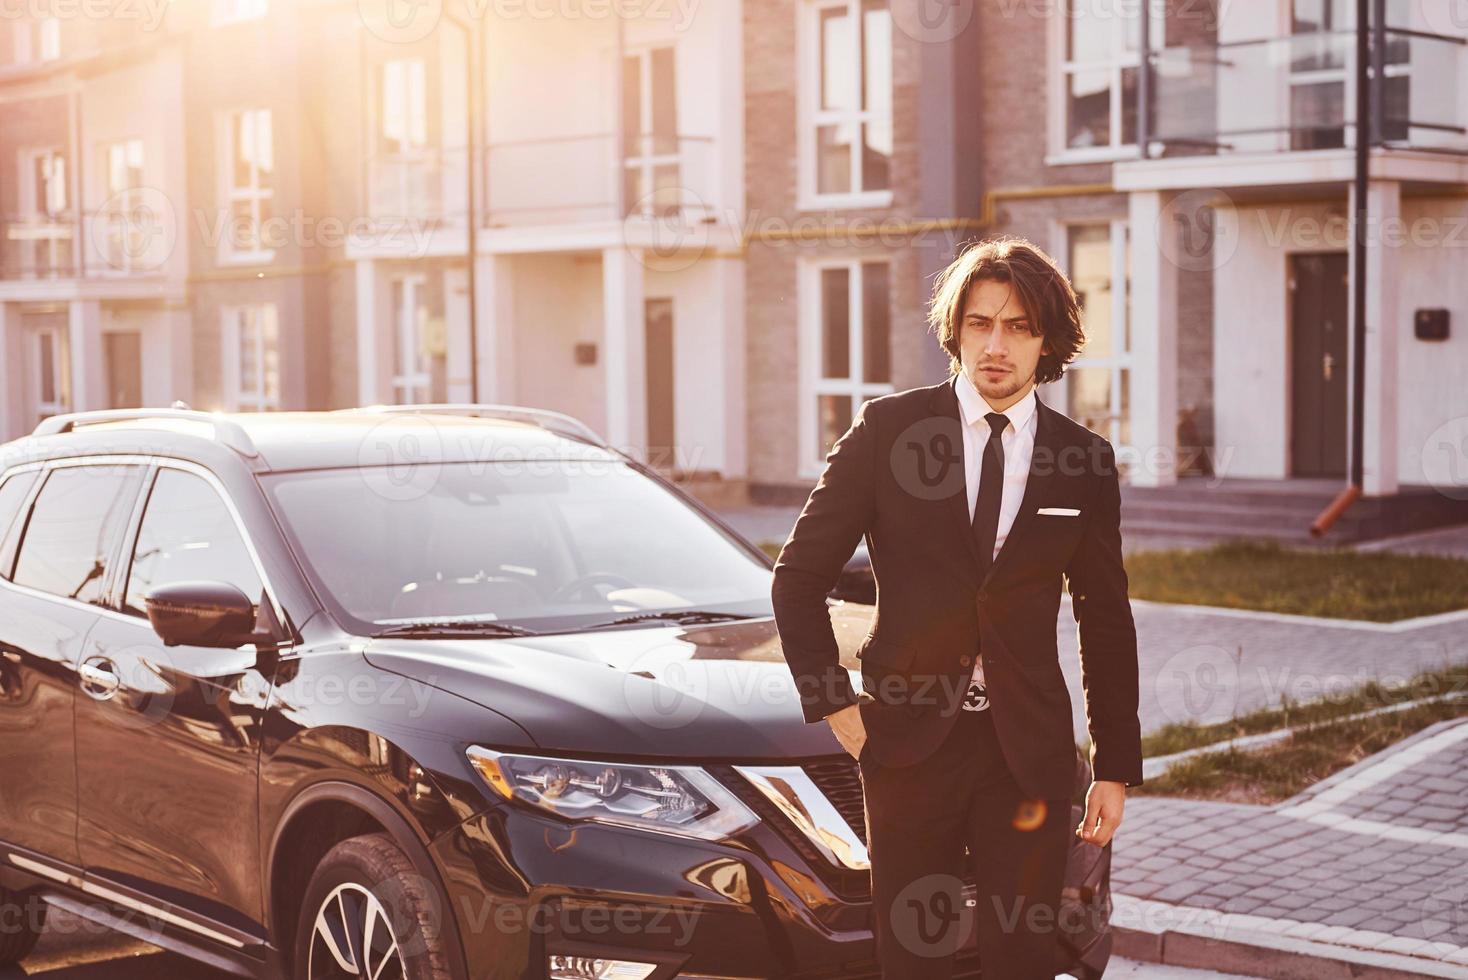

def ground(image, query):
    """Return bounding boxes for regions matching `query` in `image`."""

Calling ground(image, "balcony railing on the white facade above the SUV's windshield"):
[484,134,719,227]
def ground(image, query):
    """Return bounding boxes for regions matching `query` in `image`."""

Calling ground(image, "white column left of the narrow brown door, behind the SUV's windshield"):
[602,248,647,459]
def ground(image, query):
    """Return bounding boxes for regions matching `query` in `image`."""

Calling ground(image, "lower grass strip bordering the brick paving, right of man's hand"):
[1130,665,1468,804]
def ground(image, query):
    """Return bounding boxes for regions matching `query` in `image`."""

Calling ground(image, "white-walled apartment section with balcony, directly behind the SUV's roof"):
[330,4,746,480]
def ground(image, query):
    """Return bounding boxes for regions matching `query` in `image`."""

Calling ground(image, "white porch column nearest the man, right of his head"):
[1117,191,1182,487]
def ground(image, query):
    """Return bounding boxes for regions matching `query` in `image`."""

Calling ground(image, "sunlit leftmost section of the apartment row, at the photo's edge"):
[0,8,192,437]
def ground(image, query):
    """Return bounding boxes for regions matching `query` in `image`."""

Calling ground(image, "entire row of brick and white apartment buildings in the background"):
[0,0,1468,519]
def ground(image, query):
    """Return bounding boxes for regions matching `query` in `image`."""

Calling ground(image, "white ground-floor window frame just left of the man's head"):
[796,257,897,480]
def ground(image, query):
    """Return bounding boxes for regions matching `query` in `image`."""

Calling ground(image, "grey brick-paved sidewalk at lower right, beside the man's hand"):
[1111,719,1468,977]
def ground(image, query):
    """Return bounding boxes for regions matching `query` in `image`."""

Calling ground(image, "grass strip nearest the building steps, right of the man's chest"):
[1126,541,1468,622]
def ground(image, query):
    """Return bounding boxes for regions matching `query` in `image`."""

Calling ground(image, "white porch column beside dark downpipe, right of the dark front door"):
[1346,180,1406,497]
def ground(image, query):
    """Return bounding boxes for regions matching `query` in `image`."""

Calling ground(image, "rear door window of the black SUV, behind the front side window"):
[13,465,142,603]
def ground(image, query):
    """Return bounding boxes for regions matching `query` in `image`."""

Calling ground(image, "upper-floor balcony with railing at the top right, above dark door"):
[1116,26,1468,189]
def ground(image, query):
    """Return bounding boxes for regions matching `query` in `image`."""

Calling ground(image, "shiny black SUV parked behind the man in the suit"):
[0,406,1110,980]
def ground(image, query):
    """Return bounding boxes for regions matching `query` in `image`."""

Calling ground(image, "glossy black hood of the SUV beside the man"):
[364,603,873,761]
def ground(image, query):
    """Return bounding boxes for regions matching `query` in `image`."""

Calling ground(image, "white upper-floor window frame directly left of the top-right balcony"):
[1045,0,1167,166]
